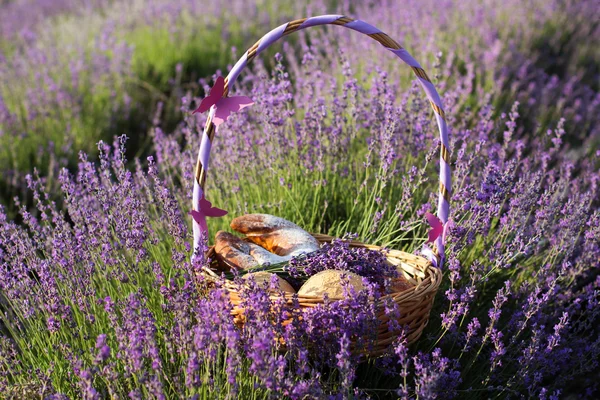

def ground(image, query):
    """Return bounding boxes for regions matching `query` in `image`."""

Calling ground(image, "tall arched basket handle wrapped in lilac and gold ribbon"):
[192,15,451,266]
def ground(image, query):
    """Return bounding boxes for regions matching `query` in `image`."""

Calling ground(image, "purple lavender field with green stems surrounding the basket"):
[0,0,600,399]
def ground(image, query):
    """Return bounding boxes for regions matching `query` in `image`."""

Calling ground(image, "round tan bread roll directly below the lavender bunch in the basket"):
[298,269,364,299]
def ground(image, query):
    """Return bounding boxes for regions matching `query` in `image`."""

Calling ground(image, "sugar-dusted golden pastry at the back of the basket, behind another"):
[231,214,319,260]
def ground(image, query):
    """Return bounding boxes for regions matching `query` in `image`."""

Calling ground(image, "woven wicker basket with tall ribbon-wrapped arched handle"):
[193,15,451,356]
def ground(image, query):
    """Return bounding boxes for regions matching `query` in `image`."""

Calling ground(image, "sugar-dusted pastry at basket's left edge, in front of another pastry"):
[215,231,288,269]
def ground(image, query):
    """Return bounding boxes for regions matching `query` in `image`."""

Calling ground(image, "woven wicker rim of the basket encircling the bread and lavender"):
[199,233,442,306]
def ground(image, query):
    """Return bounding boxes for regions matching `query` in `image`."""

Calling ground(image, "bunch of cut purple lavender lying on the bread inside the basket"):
[283,239,398,286]
